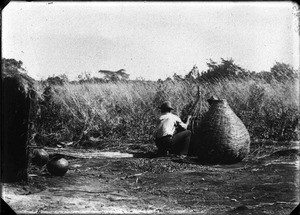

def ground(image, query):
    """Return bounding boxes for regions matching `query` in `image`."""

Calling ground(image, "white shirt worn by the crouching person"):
[154,112,187,138]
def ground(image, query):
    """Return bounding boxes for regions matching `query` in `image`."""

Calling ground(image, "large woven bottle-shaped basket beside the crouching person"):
[193,96,250,164]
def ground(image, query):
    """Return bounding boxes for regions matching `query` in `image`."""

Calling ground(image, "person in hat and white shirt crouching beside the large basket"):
[154,102,191,157]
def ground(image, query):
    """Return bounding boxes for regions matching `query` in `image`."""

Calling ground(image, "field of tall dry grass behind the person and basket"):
[36,76,299,145]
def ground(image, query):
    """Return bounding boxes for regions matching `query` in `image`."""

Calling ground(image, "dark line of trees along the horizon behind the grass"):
[2,58,298,85]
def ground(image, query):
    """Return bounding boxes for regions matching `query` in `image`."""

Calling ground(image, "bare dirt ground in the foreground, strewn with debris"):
[2,142,300,214]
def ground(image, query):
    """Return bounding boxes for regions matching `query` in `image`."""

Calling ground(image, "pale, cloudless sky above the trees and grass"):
[1,1,299,80]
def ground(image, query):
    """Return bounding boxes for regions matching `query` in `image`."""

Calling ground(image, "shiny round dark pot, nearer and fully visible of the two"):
[47,157,69,176]
